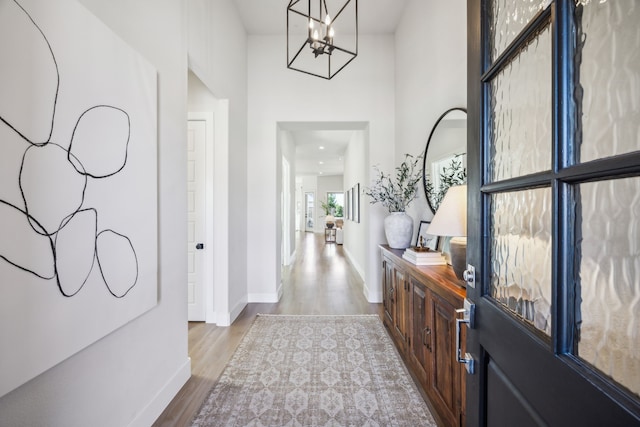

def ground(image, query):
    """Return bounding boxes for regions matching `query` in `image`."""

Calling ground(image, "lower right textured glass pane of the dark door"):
[576,178,640,395]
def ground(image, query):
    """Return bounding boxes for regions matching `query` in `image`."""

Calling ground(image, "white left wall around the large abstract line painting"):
[0,0,190,427]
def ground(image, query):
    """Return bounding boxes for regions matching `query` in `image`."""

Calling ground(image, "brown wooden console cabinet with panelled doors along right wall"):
[380,245,466,426]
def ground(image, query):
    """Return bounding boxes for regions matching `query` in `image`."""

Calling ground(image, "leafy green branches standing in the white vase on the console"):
[363,154,422,212]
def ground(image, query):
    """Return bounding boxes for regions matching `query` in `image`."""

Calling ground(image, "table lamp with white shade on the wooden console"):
[427,185,467,280]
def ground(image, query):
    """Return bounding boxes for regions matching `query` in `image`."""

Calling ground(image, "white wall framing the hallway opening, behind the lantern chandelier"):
[247,36,395,302]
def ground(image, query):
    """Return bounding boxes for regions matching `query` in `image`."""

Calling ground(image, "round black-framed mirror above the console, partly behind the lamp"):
[422,107,467,214]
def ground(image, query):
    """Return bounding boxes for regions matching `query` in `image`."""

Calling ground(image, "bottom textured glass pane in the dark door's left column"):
[491,188,551,335]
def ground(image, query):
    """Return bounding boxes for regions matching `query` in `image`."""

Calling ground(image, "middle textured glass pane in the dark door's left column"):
[489,27,552,181]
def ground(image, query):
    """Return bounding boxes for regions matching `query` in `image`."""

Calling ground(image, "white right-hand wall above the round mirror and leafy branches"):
[395,0,467,232]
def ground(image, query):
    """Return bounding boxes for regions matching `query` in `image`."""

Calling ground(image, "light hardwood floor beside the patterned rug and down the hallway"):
[154,233,382,426]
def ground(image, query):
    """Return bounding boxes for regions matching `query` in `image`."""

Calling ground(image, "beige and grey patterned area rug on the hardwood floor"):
[192,315,436,427]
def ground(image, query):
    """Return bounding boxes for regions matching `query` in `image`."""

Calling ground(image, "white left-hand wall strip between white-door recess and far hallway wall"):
[188,0,249,325]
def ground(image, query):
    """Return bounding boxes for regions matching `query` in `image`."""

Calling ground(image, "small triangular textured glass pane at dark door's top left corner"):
[489,0,551,61]
